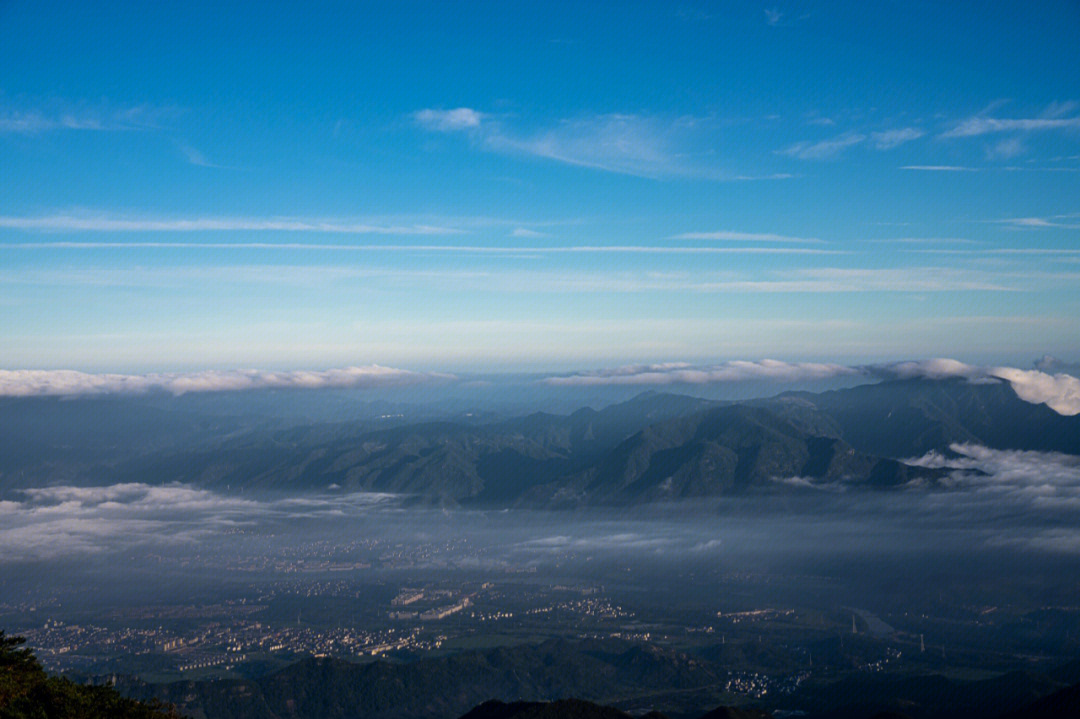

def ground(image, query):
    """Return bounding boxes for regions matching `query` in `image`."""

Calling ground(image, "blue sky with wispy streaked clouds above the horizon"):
[0,2,1080,371]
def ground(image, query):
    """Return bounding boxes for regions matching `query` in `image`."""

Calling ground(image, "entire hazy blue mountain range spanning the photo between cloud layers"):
[0,380,1080,506]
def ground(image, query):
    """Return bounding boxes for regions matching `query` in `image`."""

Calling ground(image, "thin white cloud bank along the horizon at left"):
[0,365,456,397]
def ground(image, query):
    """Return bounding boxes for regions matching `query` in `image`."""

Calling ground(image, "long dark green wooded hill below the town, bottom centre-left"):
[124,640,723,719]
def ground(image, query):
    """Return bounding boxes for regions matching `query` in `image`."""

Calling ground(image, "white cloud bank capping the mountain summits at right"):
[542,357,1080,416]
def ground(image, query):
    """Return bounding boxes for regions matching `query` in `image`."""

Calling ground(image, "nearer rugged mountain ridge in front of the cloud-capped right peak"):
[105,395,934,506]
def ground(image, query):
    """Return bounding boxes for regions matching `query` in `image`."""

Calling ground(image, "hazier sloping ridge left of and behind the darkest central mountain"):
[105,393,715,505]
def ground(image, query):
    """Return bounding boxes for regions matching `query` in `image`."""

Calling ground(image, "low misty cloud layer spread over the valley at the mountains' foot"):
[0,444,1080,561]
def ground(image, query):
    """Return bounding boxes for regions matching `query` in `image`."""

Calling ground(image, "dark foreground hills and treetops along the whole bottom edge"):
[0,632,1080,719]
